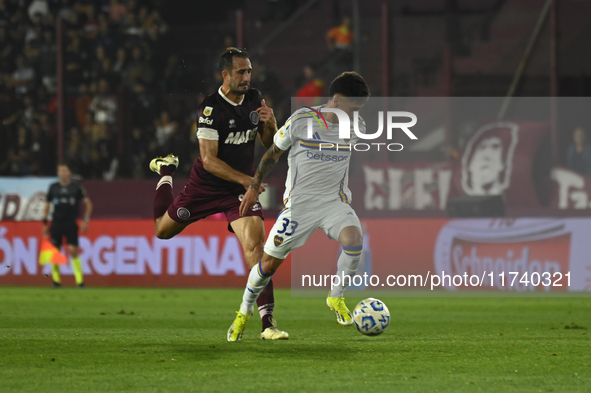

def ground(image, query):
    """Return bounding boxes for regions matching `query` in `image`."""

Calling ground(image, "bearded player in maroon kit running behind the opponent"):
[150,48,289,340]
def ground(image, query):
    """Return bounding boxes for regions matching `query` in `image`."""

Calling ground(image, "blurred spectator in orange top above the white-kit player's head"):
[326,16,353,75]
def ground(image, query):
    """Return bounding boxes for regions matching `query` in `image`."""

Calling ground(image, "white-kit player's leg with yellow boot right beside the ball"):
[326,226,363,326]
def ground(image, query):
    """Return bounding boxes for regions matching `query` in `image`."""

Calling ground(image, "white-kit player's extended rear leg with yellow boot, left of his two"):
[228,253,289,341]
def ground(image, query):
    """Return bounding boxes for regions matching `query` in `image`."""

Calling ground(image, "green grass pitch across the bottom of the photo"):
[0,287,591,393]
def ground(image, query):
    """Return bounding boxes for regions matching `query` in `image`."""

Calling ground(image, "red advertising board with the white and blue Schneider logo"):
[291,218,591,296]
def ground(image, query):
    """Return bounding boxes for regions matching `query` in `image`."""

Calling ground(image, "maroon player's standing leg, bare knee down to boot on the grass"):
[231,216,289,340]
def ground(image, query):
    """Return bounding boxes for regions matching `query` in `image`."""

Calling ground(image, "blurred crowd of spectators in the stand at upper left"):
[0,0,196,180]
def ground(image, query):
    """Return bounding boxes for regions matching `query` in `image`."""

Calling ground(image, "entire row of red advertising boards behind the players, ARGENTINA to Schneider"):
[0,218,591,292]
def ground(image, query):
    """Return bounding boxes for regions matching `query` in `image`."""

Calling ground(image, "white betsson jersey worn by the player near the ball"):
[273,106,365,207]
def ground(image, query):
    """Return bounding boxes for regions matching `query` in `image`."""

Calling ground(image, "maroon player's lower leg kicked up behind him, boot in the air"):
[150,154,188,239]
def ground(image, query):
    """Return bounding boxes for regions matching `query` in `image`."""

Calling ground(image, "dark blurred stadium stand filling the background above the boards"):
[0,0,591,216]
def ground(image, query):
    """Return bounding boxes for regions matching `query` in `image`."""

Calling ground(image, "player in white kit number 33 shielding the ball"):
[227,72,369,341]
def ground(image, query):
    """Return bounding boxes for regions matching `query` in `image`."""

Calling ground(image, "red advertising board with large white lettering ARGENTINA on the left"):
[0,220,290,288]
